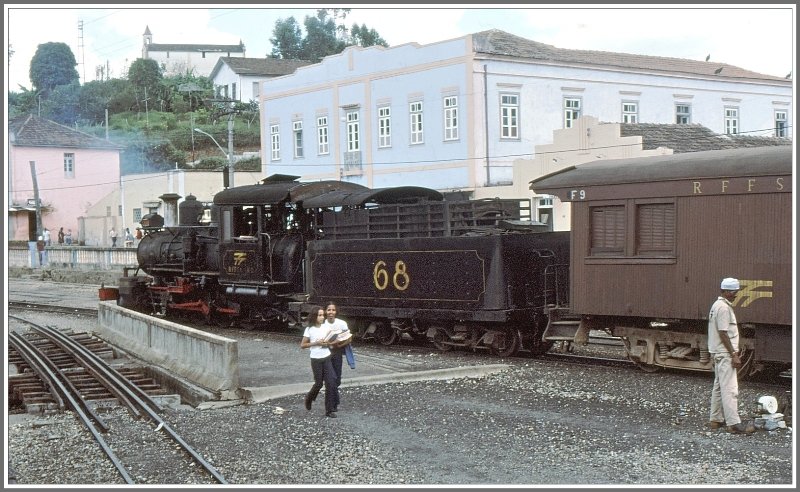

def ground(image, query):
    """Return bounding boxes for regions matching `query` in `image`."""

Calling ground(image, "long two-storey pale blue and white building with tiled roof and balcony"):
[259,29,793,198]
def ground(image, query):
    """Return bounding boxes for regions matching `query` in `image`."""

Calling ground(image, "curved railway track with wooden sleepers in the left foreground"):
[9,315,227,484]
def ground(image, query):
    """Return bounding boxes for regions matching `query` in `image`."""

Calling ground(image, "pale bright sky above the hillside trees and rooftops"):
[4,4,795,92]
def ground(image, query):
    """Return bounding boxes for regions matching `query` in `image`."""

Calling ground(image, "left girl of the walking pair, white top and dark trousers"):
[300,306,339,418]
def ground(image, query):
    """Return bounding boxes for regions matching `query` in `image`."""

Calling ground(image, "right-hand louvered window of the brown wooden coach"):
[636,203,675,255]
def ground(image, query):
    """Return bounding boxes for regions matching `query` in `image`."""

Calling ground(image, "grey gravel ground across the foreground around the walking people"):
[8,355,794,486]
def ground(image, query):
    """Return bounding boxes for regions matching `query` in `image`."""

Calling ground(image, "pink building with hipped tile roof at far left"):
[7,115,123,244]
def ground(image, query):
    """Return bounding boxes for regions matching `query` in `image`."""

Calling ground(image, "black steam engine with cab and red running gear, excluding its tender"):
[120,175,364,325]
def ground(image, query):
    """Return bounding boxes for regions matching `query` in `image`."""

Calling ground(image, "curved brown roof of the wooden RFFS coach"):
[530,145,792,194]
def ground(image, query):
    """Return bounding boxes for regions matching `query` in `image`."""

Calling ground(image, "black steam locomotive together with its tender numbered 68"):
[119,175,569,355]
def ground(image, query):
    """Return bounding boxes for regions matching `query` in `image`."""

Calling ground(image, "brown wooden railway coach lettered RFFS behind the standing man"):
[531,146,794,375]
